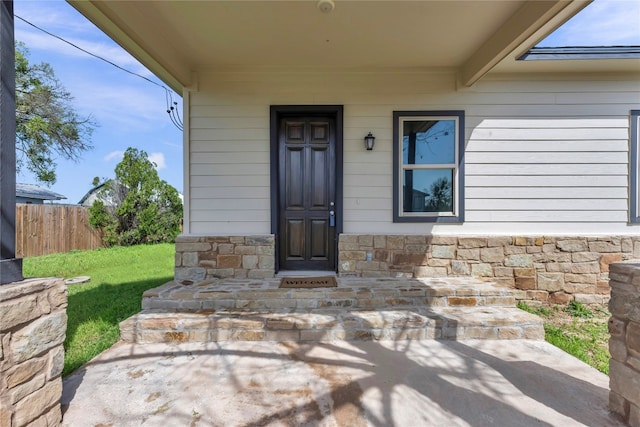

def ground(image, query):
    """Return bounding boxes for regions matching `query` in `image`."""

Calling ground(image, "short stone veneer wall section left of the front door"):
[175,235,275,282]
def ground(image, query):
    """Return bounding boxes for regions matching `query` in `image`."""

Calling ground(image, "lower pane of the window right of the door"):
[402,169,453,212]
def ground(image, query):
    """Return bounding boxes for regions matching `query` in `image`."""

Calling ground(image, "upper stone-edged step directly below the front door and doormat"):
[142,277,516,312]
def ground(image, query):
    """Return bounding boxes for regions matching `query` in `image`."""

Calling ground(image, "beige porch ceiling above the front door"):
[69,0,589,91]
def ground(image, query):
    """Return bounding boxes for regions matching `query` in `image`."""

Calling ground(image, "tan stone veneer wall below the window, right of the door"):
[338,234,640,304]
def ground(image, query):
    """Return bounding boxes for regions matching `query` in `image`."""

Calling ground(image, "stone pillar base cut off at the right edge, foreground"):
[609,264,640,427]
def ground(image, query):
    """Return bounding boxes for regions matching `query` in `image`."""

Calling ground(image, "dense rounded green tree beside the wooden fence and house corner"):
[89,148,182,246]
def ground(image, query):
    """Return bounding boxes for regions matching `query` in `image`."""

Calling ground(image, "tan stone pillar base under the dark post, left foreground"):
[0,279,67,427]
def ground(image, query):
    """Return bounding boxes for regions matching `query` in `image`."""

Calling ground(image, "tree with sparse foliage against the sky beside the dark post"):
[16,42,96,184]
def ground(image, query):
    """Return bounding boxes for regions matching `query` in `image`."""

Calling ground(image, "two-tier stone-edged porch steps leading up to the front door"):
[120,277,544,343]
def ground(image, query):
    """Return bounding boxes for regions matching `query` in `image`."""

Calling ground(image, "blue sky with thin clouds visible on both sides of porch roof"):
[14,0,640,203]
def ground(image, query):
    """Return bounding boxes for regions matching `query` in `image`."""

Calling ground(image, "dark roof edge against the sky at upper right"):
[518,46,640,61]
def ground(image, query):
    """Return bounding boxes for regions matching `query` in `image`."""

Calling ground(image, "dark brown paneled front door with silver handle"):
[277,115,337,270]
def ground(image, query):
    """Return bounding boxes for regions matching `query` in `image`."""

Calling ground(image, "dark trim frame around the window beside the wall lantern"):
[393,110,465,223]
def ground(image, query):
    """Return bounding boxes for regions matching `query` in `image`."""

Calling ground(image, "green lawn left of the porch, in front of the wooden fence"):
[23,244,175,376]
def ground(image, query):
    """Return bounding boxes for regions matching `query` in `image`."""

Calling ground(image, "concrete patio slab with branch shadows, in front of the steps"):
[62,340,623,427]
